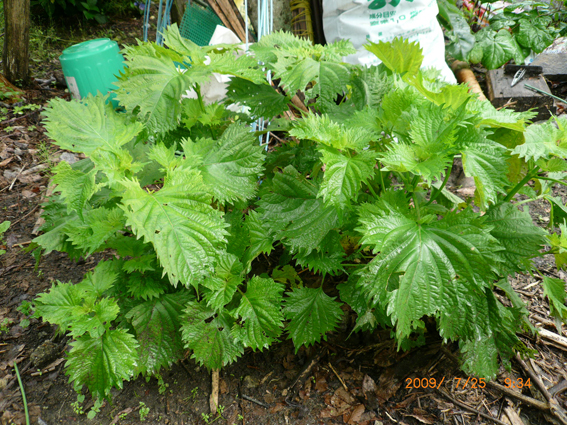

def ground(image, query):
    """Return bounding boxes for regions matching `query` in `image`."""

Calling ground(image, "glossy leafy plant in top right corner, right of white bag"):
[437,0,567,69]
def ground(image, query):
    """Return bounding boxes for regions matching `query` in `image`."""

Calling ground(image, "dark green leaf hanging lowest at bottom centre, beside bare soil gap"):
[284,288,343,352]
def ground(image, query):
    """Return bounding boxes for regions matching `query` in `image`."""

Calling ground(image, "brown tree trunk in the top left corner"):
[2,0,30,83]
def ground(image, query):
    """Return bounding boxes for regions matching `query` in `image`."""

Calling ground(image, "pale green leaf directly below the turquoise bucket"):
[44,95,143,155]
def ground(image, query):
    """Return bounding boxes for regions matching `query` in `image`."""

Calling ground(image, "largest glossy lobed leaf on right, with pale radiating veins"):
[359,199,501,341]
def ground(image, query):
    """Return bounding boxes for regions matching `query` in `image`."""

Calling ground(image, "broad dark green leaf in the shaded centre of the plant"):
[258,166,339,254]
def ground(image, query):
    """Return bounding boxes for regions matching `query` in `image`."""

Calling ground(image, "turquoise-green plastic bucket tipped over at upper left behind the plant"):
[59,38,124,107]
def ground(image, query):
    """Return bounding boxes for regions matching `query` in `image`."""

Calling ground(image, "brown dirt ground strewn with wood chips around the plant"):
[0,9,567,425]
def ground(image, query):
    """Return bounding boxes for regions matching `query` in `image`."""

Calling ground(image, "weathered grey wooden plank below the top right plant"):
[486,69,555,120]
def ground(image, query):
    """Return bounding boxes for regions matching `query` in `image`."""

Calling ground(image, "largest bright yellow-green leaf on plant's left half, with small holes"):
[122,170,226,286]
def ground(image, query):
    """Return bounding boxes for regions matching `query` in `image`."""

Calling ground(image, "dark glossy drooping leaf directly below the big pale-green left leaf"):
[126,291,192,374]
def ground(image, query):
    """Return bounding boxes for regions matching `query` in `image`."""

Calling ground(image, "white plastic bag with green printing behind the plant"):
[323,0,457,84]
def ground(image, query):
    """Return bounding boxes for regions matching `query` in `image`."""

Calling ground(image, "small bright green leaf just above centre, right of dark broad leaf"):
[317,147,376,208]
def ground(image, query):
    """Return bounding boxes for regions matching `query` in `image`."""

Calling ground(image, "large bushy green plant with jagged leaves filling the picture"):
[34,26,567,398]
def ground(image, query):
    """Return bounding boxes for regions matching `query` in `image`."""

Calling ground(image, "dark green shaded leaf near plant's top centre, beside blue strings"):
[227,78,289,119]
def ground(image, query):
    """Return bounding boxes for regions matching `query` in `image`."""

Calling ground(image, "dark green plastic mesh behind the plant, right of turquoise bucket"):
[179,2,222,46]
